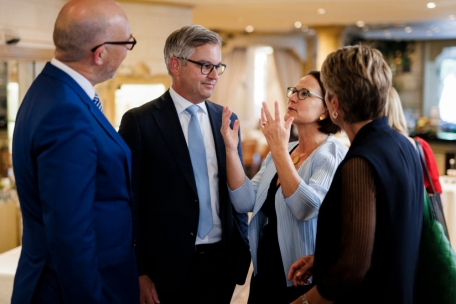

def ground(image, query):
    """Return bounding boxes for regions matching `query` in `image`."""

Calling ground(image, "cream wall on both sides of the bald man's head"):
[0,0,192,75]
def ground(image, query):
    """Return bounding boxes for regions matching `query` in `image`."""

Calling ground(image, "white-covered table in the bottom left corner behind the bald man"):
[0,247,22,304]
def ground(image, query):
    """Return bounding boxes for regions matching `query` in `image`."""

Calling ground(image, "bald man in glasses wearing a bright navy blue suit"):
[11,0,139,304]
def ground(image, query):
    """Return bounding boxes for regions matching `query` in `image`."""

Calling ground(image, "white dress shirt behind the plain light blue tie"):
[169,87,222,245]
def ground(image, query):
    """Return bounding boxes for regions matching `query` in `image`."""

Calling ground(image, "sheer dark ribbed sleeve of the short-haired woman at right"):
[317,158,376,299]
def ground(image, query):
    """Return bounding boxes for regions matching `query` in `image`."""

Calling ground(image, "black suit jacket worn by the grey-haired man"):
[119,91,250,295]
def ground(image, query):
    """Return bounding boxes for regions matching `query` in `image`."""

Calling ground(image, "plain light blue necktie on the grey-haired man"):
[186,105,212,239]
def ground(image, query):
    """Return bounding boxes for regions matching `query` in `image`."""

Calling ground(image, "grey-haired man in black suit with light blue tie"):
[119,25,250,304]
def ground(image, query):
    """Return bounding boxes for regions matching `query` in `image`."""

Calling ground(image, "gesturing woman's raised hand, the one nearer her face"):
[260,101,294,153]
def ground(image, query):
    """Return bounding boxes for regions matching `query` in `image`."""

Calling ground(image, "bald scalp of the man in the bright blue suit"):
[54,0,128,62]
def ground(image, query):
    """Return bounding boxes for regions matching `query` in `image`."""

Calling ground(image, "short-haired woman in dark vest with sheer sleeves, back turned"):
[288,46,424,304]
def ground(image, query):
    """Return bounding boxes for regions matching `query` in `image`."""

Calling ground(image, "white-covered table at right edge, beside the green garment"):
[440,176,456,251]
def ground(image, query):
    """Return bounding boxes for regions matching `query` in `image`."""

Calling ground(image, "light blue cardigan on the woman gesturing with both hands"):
[229,135,348,286]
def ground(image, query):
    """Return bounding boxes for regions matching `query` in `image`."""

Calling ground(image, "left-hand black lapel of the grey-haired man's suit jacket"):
[151,91,198,195]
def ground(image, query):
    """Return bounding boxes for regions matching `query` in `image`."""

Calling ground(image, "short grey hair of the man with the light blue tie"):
[163,25,222,76]
